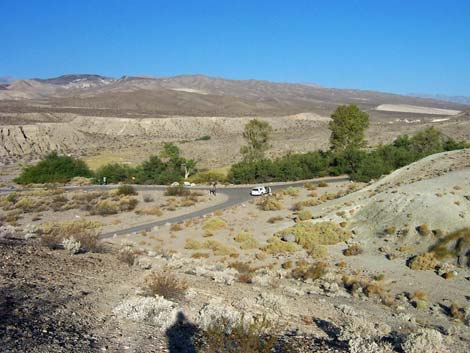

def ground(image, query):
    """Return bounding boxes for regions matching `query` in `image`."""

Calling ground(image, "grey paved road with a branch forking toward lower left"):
[0,176,350,238]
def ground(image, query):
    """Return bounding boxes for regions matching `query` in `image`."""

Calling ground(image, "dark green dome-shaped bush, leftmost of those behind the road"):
[14,152,92,184]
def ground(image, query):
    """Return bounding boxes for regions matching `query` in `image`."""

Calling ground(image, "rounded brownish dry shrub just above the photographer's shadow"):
[145,271,188,301]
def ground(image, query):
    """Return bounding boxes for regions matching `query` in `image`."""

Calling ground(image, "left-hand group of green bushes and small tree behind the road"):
[15,143,196,184]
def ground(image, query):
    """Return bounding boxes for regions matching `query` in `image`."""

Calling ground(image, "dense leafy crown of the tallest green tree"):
[328,104,369,152]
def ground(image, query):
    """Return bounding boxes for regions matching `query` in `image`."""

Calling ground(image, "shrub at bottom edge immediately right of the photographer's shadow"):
[198,317,280,353]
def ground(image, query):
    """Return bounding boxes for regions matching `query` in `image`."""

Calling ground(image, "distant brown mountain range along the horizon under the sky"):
[0,74,468,119]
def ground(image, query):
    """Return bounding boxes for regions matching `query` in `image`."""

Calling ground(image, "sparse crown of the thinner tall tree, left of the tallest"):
[241,119,273,161]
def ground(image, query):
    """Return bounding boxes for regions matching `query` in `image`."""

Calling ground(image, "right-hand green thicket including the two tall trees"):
[227,105,470,184]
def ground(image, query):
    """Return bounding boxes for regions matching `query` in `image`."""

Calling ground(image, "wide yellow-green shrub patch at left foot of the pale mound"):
[276,222,351,252]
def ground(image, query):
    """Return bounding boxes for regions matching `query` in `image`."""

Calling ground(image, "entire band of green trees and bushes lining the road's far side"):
[15,105,470,184]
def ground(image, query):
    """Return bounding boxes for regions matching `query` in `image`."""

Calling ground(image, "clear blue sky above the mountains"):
[0,0,470,95]
